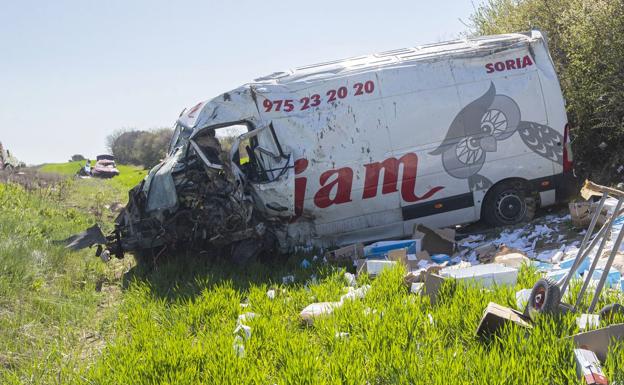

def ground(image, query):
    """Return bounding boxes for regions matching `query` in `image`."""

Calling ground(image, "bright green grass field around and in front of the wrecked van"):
[0,165,624,385]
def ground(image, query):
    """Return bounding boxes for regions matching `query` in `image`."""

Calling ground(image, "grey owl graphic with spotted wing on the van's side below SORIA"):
[430,83,563,191]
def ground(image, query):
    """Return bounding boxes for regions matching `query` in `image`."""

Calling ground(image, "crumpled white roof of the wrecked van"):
[252,30,542,84]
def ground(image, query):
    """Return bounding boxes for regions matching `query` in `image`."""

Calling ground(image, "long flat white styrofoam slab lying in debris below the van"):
[440,263,518,287]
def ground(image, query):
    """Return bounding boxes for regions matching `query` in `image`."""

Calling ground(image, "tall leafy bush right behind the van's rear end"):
[470,0,624,183]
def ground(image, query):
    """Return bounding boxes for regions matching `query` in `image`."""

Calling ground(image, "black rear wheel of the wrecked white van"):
[482,180,537,226]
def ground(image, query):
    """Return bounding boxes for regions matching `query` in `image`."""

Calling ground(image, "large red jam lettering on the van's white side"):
[295,153,444,217]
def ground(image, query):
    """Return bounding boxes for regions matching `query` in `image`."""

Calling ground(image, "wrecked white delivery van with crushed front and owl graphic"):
[86,31,572,260]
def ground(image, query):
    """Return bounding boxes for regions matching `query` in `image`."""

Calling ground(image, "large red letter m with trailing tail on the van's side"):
[362,153,443,202]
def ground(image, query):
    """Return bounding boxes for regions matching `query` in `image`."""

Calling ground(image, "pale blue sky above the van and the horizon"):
[0,0,480,164]
